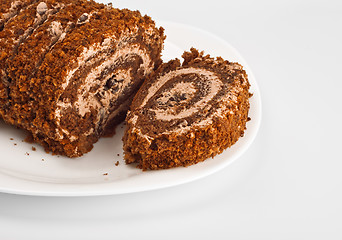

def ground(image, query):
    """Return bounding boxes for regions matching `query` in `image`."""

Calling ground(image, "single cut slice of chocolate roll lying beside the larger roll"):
[123,49,251,170]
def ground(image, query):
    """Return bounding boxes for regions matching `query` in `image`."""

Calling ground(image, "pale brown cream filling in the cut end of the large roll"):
[55,41,153,140]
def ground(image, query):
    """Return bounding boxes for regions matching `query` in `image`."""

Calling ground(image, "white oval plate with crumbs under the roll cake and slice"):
[0,22,261,196]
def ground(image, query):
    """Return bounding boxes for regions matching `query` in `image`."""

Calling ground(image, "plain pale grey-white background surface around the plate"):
[0,0,342,240]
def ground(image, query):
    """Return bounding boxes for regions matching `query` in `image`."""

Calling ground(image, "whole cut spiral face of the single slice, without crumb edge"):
[128,68,240,136]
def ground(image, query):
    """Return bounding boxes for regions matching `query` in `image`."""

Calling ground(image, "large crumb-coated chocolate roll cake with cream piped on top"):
[0,0,165,157]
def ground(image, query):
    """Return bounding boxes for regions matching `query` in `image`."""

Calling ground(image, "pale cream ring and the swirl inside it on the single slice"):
[141,68,222,121]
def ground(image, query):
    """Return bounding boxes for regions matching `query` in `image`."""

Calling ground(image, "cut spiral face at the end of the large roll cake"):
[55,39,154,140]
